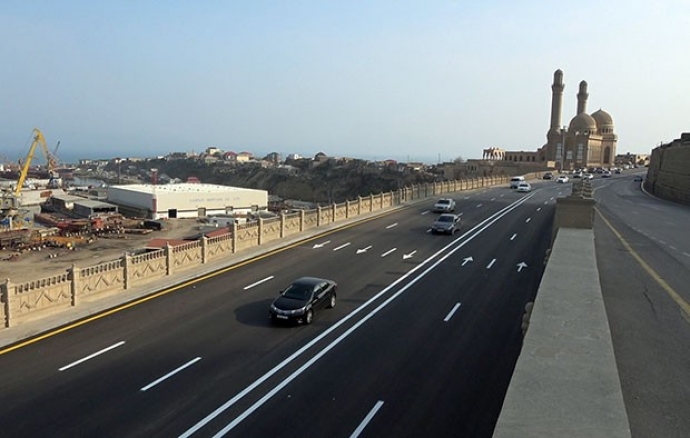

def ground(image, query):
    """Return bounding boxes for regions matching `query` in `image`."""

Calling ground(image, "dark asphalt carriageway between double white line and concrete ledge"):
[180,186,551,436]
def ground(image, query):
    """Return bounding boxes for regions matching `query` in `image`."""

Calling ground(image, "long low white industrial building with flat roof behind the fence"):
[108,183,268,219]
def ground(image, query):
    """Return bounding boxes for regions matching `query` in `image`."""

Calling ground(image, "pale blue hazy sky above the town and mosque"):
[0,0,690,163]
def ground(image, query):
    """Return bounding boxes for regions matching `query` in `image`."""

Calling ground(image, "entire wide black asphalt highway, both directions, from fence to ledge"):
[0,181,569,437]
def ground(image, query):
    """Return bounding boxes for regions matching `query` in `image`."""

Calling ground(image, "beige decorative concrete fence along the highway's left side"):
[0,175,510,328]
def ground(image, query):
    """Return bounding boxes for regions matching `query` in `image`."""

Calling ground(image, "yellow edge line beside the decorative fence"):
[0,205,404,356]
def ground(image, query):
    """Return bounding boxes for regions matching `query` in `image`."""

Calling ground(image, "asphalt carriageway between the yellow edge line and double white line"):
[0,182,543,436]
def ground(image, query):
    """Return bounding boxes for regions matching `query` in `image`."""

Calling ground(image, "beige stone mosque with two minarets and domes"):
[477,70,618,170]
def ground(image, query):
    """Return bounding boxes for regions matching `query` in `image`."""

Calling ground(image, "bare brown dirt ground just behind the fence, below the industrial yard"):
[0,219,208,284]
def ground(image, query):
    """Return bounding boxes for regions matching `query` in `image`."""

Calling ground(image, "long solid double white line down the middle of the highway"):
[180,192,530,438]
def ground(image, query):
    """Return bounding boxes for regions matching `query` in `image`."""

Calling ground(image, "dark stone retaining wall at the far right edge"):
[644,132,690,205]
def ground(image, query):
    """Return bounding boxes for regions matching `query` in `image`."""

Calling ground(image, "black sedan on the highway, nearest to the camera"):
[268,277,338,324]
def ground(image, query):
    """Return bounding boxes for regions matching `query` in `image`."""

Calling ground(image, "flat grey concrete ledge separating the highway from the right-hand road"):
[493,228,631,438]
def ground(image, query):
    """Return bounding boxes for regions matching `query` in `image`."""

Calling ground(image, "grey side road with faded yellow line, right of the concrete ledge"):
[594,172,690,438]
